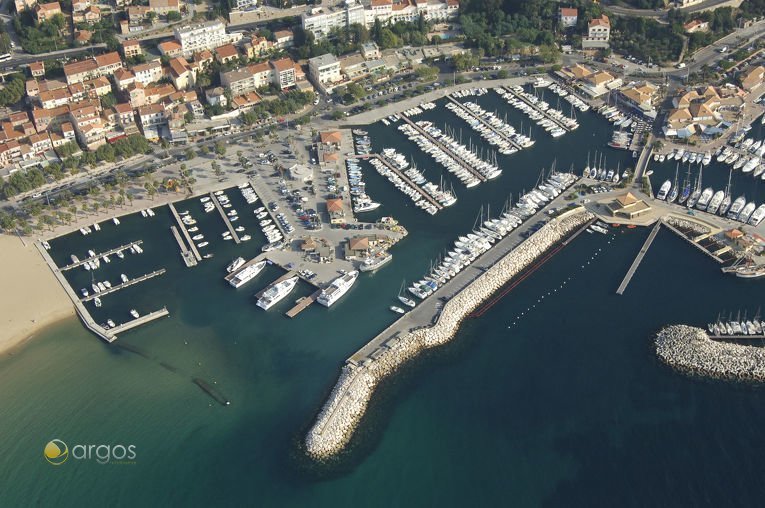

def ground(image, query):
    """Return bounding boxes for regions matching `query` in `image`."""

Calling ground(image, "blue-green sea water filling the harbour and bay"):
[0,95,765,506]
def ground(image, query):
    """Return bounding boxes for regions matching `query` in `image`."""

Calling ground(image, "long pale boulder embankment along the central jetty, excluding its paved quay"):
[305,208,593,460]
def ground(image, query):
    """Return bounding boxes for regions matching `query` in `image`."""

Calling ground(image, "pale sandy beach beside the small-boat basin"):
[0,235,75,354]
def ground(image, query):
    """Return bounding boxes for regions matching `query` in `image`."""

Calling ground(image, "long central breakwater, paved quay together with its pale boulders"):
[305,193,593,459]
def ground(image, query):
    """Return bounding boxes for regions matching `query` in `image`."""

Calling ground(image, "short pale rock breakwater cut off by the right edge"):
[655,325,765,381]
